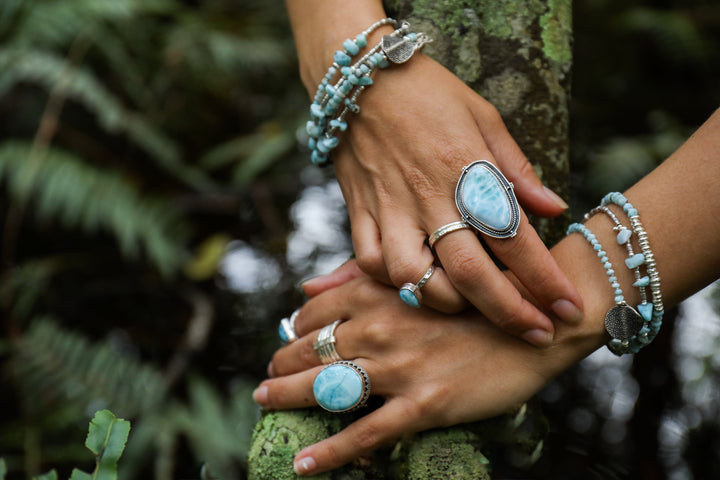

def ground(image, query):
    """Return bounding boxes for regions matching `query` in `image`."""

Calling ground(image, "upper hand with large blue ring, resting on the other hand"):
[332,54,582,346]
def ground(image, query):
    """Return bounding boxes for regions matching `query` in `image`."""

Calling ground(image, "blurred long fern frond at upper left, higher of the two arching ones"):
[0,48,213,190]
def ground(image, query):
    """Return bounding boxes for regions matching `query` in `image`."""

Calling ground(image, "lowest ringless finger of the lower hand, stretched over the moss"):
[293,398,425,475]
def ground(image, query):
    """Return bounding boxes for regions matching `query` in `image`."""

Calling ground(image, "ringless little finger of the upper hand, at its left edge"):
[351,210,391,284]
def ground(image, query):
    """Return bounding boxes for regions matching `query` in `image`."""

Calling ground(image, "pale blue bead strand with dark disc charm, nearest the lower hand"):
[567,223,644,355]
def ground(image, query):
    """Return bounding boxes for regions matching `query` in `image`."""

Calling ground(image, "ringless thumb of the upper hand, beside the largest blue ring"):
[471,99,568,217]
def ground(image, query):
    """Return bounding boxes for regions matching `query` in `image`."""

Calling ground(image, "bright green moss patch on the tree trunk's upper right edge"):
[540,0,572,65]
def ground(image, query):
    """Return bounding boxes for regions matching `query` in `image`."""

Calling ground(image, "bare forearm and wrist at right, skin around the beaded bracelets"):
[550,111,720,370]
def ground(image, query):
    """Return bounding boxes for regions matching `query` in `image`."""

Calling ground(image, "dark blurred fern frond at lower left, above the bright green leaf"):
[8,318,166,417]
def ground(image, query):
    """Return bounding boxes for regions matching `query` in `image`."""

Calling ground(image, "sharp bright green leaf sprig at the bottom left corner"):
[70,410,130,480]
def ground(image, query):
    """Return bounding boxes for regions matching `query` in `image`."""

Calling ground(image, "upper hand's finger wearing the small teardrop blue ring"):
[382,210,468,313]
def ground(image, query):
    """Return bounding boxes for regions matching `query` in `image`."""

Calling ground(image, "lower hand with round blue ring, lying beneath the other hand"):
[253,274,592,475]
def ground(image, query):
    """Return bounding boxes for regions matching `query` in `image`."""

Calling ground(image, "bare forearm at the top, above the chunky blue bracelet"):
[285,0,393,93]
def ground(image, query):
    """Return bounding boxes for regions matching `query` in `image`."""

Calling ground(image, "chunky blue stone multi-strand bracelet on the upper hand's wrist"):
[306,18,431,166]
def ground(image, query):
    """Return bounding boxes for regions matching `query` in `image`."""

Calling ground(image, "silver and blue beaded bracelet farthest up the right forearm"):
[600,192,665,353]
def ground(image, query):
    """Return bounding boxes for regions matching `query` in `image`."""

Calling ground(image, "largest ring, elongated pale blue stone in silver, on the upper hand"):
[455,160,520,238]
